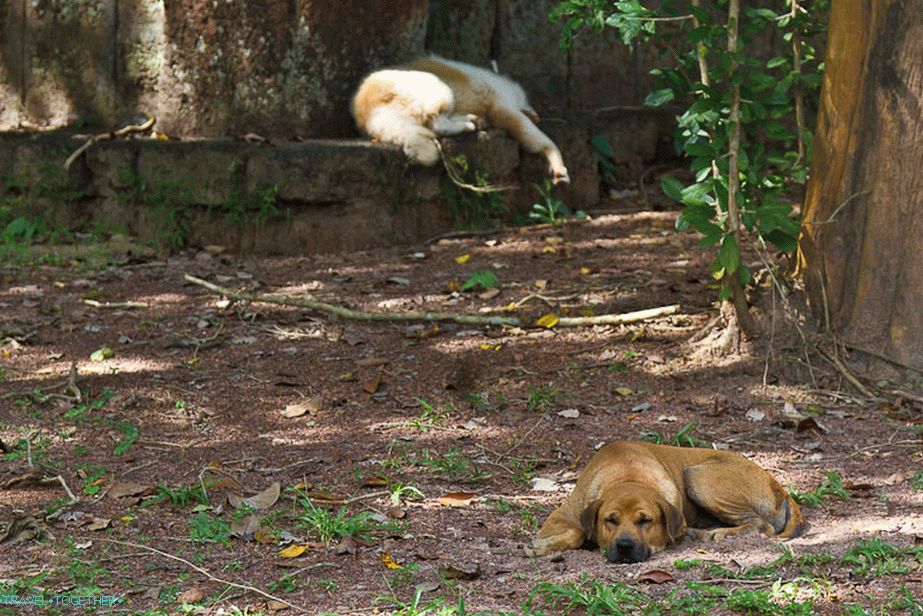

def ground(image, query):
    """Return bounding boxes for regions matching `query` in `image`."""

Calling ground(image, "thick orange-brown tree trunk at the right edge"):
[799,0,923,370]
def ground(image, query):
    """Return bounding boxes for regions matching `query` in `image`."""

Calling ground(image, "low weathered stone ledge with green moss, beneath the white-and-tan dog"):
[0,126,598,254]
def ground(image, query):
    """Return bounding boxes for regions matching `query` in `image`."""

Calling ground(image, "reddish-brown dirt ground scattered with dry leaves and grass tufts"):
[0,205,923,614]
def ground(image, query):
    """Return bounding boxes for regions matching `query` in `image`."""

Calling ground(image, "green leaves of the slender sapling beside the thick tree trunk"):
[550,0,830,298]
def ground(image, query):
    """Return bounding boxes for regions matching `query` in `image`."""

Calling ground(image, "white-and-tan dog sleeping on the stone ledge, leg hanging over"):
[352,56,570,184]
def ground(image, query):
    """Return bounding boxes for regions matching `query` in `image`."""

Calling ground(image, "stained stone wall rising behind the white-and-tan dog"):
[0,0,654,140]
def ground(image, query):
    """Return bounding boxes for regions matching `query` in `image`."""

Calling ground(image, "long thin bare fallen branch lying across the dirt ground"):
[183,274,679,327]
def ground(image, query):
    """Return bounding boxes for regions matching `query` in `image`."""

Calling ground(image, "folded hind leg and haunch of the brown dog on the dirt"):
[683,460,801,541]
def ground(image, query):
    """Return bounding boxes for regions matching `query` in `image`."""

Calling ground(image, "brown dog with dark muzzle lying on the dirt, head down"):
[526,441,804,563]
